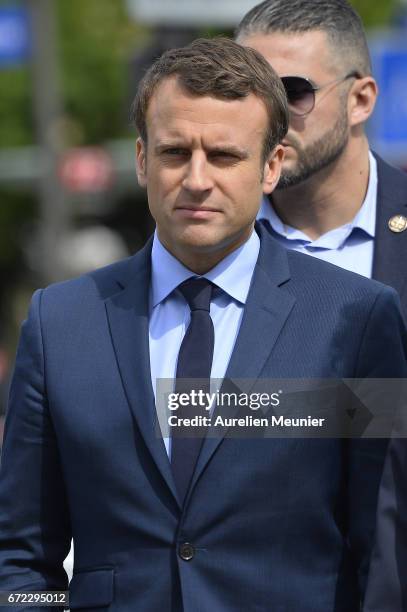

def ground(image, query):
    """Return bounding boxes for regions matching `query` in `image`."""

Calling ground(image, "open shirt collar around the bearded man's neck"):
[257,151,377,249]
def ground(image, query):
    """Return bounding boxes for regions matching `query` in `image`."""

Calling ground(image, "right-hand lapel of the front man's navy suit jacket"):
[186,226,295,501]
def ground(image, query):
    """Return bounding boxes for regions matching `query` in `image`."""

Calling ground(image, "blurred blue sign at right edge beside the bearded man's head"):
[369,30,407,163]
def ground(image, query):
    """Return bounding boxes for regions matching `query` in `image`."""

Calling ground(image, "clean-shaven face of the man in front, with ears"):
[137,77,283,273]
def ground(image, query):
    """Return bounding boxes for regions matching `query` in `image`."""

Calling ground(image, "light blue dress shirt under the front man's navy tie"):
[149,232,260,456]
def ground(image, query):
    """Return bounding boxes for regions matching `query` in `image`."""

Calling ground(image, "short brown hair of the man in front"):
[131,37,288,159]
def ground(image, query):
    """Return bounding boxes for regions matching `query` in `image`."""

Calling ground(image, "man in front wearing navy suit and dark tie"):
[0,39,406,612]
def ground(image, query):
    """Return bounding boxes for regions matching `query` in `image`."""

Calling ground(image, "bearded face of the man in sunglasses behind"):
[242,30,349,189]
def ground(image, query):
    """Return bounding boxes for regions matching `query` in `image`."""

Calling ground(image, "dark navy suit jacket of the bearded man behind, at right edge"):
[332,154,407,612]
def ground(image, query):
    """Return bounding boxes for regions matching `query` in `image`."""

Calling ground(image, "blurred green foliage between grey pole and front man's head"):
[58,0,148,143]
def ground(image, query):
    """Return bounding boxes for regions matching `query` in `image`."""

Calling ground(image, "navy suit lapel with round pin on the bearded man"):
[373,156,407,304]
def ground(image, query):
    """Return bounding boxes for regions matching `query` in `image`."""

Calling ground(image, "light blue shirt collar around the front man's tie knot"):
[151,231,260,308]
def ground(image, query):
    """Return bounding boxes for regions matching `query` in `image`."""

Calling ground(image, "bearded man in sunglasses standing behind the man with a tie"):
[236,0,407,316]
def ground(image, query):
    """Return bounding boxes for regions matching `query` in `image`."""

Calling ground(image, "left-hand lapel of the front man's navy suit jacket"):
[105,244,182,510]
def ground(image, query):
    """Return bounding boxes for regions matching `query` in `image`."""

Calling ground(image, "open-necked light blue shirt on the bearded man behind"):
[257,152,377,278]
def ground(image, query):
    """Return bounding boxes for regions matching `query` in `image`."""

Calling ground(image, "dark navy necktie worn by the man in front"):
[171,278,215,503]
